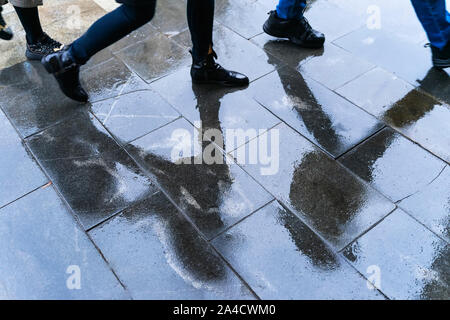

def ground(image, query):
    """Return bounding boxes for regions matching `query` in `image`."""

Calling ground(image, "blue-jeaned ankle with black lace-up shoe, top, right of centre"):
[263,0,325,48]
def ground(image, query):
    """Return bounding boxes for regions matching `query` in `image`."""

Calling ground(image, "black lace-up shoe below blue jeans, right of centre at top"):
[263,11,325,49]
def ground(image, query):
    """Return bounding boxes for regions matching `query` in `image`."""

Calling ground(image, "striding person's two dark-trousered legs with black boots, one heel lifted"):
[42,0,249,102]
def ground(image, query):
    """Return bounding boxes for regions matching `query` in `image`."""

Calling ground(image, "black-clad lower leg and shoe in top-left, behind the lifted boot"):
[0,0,62,60]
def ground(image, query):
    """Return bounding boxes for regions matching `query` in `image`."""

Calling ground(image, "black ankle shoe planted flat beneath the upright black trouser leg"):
[191,51,249,87]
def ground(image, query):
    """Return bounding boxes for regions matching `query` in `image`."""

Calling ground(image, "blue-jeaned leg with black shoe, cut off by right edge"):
[411,0,450,68]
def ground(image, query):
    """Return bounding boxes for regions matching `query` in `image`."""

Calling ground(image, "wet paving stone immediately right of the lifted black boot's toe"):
[81,58,148,102]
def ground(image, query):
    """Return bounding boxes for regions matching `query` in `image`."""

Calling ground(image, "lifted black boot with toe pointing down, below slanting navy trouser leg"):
[41,48,89,102]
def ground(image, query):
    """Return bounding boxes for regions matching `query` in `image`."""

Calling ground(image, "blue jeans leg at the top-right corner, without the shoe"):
[411,0,450,49]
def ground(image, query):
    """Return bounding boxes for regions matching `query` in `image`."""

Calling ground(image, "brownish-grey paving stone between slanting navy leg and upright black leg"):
[115,32,192,82]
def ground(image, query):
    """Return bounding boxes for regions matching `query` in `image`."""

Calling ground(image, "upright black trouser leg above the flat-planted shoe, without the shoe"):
[187,0,214,63]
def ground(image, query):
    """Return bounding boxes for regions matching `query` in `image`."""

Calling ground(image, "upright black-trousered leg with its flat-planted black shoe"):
[187,0,249,86]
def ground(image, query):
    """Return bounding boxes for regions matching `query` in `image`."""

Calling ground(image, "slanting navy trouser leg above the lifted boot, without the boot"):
[70,0,156,64]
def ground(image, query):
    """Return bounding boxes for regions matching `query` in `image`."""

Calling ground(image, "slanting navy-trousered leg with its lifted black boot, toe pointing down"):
[42,0,156,102]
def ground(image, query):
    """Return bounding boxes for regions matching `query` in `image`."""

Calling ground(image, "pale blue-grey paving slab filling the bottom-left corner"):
[0,187,129,299]
